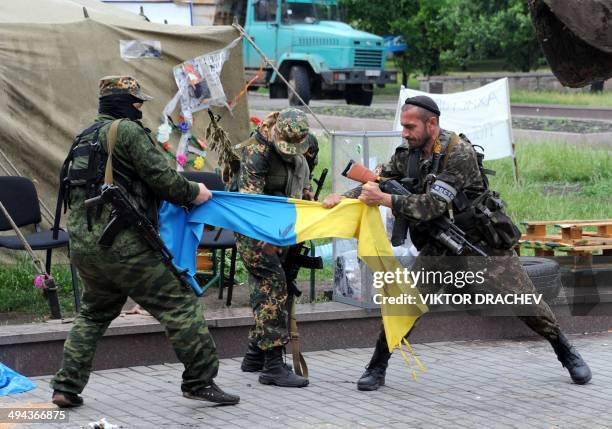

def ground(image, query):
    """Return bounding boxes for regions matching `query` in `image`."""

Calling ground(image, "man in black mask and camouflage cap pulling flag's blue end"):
[51,76,240,407]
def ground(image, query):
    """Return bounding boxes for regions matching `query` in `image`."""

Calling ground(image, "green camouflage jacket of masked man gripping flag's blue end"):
[68,115,199,257]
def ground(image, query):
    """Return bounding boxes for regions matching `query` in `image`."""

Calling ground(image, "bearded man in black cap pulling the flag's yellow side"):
[323,96,591,390]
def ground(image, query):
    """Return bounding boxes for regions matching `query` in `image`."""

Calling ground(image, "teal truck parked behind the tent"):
[237,0,397,106]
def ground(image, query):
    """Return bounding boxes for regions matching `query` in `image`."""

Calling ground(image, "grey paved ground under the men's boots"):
[0,334,612,429]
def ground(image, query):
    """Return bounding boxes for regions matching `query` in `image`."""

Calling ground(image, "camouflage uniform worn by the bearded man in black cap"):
[345,129,560,341]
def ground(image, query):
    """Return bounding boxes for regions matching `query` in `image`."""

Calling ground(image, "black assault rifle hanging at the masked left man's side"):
[85,184,204,296]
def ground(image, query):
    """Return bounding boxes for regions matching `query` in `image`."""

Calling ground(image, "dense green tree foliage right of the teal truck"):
[340,0,544,77]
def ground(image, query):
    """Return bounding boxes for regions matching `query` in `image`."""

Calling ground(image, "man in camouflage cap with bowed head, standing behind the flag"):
[236,108,310,387]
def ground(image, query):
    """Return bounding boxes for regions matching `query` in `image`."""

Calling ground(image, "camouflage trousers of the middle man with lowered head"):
[236,234,289,350]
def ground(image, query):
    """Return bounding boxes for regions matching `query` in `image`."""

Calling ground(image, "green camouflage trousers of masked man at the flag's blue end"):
[51,250,219,394]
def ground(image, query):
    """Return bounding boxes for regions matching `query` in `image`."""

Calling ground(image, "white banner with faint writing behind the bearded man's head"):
[393,78,513,159]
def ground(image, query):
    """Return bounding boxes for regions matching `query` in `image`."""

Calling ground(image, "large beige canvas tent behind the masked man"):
[0,0,248,227]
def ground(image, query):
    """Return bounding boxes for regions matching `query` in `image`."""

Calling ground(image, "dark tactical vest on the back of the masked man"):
[53,120,158,233]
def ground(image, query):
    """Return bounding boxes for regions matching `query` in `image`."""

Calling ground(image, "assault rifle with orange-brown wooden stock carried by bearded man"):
[342,160,487,256]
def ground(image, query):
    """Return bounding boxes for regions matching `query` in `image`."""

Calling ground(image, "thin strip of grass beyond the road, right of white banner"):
[510,90,612,107]
